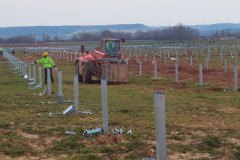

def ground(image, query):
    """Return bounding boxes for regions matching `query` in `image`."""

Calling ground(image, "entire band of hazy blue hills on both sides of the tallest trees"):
[0,23,240,39]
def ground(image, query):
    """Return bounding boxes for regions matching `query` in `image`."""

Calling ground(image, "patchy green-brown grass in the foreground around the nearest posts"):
[0,49,240,160]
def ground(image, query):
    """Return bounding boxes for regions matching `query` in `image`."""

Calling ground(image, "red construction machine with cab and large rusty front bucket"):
[75,38,129,83]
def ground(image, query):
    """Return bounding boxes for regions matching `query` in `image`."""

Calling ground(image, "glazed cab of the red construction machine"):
[101,39,121,58]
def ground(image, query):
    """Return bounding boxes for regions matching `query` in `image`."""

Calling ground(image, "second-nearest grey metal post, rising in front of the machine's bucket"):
[101,78,108,134]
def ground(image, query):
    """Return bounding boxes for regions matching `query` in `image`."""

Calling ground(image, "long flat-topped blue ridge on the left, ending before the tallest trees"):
[0,24,150,38]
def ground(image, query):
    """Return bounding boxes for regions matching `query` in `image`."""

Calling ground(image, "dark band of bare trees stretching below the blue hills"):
[0,24,240,43]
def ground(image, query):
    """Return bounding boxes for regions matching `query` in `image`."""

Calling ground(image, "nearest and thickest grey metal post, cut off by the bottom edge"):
[154,91,167,160]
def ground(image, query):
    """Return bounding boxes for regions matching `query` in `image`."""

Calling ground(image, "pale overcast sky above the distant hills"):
[0,0,240,27]
